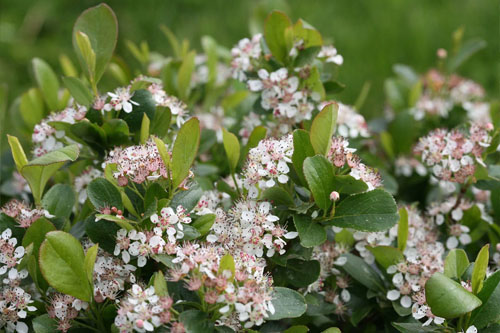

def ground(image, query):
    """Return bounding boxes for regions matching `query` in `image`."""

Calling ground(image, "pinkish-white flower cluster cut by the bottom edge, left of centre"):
[115,284,177,333]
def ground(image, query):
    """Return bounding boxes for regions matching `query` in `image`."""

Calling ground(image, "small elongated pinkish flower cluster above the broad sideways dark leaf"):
[327,137,382,191]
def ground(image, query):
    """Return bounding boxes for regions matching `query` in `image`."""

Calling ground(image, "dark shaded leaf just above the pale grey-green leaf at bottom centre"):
[285,259,321,288]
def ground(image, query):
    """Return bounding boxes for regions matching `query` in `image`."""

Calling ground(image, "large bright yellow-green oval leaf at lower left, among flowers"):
[40,231,93,302]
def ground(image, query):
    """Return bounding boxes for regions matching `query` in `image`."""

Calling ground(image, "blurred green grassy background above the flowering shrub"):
[0,0,500,117]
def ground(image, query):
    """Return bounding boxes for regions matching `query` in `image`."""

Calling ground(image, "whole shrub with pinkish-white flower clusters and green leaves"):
[0,5,500,333]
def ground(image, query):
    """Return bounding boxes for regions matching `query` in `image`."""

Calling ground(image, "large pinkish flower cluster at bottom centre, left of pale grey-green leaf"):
[170,243,275,330]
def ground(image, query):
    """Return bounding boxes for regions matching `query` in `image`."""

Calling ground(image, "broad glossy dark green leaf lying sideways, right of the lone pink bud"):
[326,189,398,231]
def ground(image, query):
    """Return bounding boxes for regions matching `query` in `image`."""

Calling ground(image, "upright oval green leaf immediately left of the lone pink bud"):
[304,155,333,212]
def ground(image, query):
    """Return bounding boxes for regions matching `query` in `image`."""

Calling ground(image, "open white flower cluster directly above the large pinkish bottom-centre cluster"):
[207,200,297,257]
